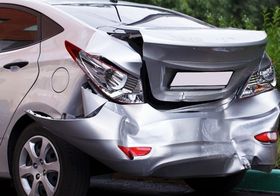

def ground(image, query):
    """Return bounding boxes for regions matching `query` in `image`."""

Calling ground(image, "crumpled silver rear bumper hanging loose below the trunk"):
[29,89,280,178]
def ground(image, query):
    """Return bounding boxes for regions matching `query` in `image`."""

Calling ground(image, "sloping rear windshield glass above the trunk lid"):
[57,4,208,28]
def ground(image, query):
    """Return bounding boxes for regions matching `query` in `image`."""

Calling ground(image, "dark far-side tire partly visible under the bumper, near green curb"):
[185,171,245,193]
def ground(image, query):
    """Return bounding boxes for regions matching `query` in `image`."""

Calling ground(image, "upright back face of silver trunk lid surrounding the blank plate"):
[143,43,264,102]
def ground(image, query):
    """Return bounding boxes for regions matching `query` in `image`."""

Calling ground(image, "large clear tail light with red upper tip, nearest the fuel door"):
[65,41,144,103]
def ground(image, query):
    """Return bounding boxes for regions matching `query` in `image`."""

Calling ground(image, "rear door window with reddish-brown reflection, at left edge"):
[0,7,40,53]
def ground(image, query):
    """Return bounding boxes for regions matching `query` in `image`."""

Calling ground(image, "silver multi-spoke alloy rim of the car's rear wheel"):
[19,136,60,196]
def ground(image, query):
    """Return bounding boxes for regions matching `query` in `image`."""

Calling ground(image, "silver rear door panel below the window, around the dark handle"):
[0,44,40,143]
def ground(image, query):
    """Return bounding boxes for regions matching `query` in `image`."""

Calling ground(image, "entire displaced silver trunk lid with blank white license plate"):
[139,28,267,102]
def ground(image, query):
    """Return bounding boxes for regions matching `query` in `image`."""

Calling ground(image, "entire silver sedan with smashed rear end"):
[0,0,280,196]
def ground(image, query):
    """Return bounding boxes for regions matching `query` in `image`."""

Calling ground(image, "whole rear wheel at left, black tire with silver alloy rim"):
[12,123,90,196]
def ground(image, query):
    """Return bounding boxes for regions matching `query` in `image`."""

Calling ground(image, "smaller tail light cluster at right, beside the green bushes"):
[240,54,276,98]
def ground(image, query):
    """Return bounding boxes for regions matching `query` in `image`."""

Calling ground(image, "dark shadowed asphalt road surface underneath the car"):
[0,177,273,196]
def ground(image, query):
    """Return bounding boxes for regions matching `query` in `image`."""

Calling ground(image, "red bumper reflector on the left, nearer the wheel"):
[119,146,152,160]
